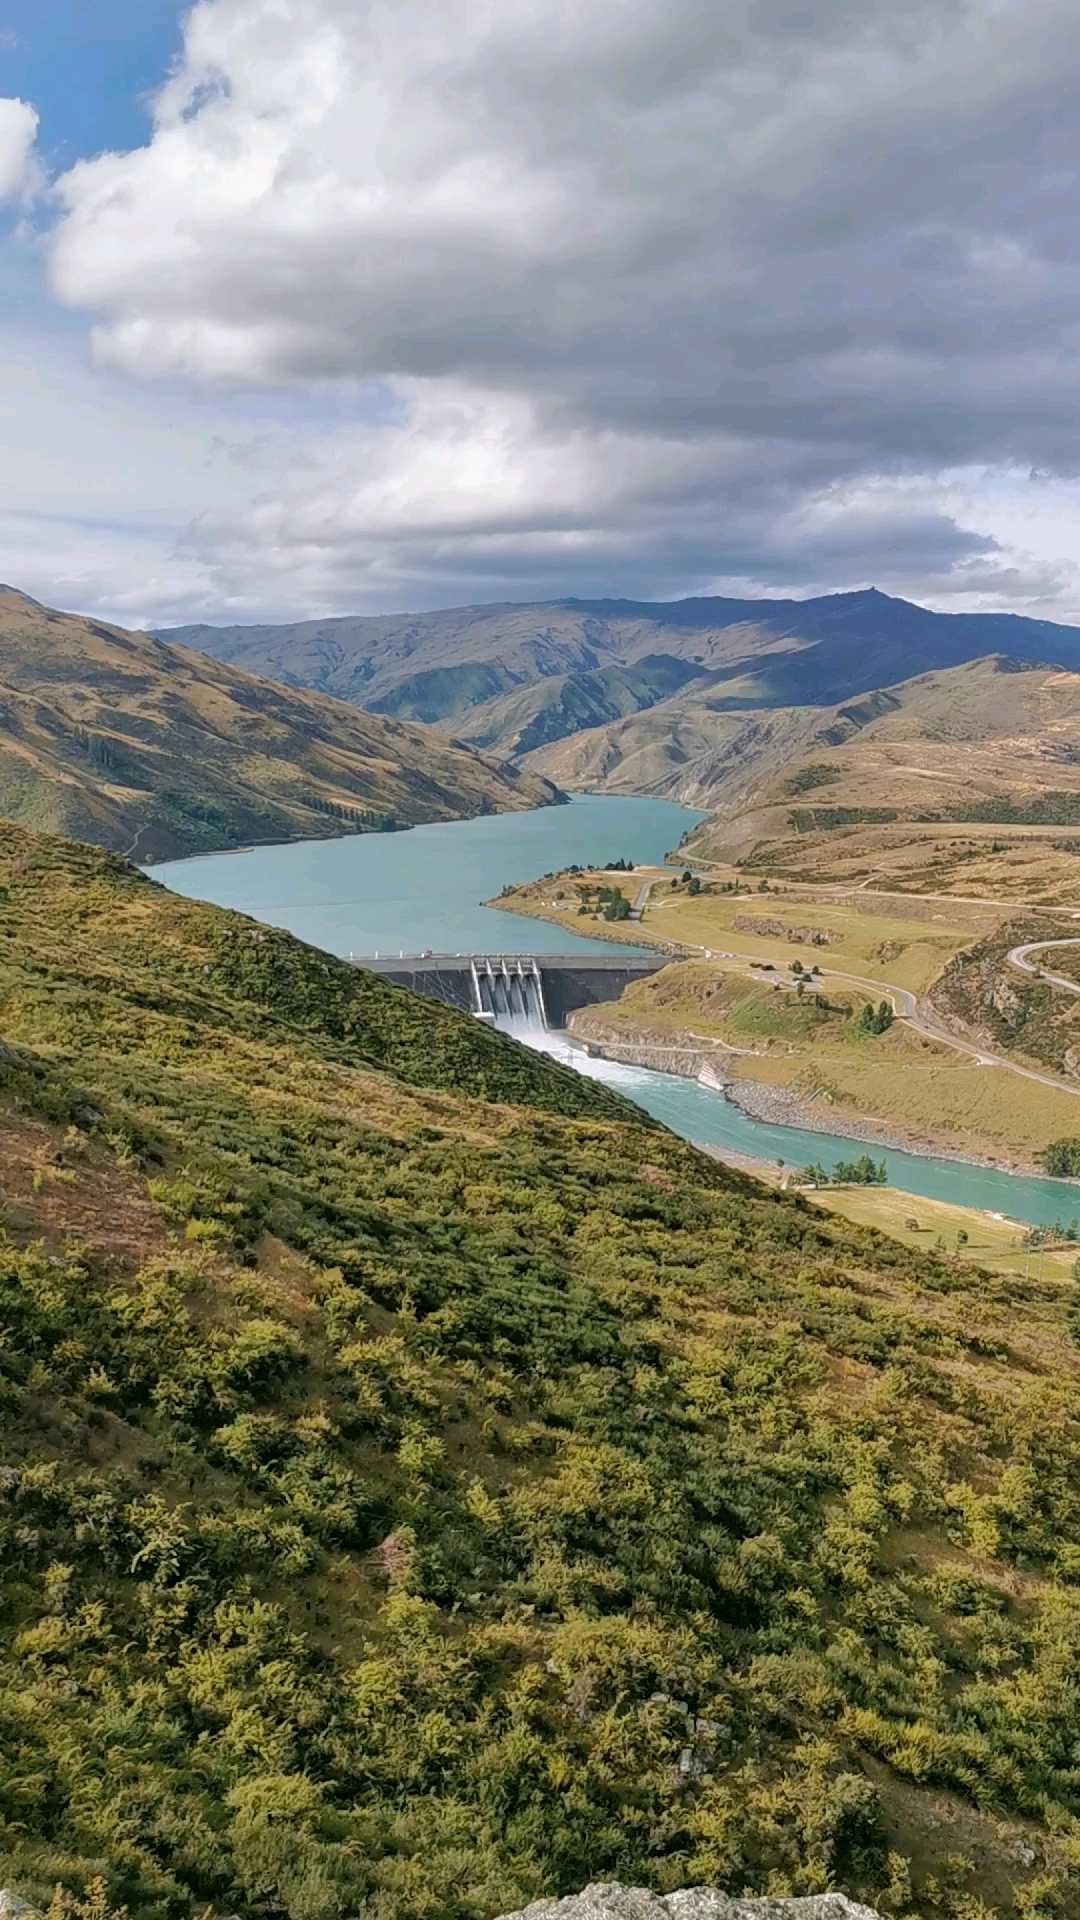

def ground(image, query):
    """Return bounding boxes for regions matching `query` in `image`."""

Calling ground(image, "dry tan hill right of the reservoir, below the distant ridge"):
[661,657,1080,883]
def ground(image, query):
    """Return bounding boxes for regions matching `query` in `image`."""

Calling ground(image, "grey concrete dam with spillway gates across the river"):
[350,952,671,1027]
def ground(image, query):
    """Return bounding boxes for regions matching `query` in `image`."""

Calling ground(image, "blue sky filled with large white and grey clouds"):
[0,0,1080,626]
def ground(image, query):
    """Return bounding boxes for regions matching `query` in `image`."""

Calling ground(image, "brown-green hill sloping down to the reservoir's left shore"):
[0,588,559,858]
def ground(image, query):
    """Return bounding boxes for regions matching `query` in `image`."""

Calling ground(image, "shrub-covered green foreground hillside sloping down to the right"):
[0,824,1080,1920]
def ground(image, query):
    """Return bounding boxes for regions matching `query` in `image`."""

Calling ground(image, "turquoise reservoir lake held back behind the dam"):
[154,795,703,954]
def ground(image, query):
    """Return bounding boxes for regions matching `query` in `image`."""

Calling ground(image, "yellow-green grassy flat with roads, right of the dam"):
[505,870,1080,1171]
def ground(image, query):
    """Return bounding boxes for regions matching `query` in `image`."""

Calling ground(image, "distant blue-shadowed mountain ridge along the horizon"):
[161,588,1080,756]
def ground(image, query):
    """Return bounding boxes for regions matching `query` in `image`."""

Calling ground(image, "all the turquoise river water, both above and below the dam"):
[154,795,1080,1225]
